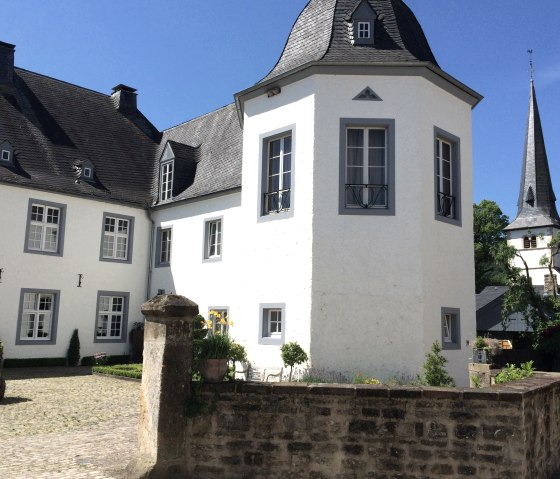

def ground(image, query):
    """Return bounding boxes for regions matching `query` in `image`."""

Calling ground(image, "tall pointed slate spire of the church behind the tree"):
[506,77,560,230]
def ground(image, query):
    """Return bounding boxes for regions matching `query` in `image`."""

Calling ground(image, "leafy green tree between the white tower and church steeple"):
[473,200,509,293]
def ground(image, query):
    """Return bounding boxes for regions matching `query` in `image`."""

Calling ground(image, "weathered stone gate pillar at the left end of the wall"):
[126,295,198,479]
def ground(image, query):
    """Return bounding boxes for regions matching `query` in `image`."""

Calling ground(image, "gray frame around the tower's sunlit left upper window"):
[257,124,296,223]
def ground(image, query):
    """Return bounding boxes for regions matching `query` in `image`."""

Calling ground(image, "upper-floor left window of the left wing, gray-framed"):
[24,199,66,256]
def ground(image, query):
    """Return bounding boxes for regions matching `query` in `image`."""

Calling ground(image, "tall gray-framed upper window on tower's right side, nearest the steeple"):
[434,127,461,226]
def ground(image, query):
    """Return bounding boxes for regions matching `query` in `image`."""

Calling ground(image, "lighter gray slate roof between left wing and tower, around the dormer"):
[153,103,243,202]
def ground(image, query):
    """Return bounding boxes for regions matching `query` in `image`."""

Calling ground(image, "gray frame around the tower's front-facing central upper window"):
[338,118,396,216]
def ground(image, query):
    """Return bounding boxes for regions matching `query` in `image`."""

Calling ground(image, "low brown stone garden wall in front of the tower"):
[185,374,560,479]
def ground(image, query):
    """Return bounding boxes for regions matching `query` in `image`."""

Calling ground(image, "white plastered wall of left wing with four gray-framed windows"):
[0,185,150,358]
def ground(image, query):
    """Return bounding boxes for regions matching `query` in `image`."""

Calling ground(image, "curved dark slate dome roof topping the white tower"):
[261,0,438,83]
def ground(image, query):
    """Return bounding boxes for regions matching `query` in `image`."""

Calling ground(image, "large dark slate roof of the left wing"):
[0,68,159,206]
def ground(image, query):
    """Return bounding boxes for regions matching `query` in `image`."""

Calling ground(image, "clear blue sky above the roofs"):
[0,0,560,220]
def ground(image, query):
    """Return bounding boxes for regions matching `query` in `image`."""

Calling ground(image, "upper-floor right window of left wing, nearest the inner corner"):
[99,213,134,263]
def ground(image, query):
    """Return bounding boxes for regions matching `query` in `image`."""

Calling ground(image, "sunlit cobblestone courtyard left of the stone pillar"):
[0,368,140,479]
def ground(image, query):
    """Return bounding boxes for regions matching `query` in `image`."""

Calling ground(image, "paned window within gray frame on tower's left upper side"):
[264,135,292,215]
